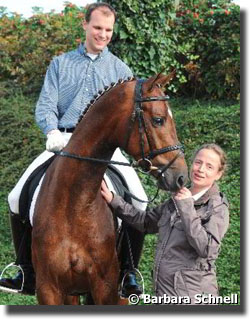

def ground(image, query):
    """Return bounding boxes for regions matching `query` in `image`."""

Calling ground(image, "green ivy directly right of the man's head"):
[107,0,174,77]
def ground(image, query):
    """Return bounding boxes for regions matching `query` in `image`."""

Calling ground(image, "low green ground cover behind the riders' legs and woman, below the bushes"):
[0,94,240,305]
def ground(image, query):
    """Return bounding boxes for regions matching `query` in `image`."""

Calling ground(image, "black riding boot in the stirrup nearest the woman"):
[121,225,144,297]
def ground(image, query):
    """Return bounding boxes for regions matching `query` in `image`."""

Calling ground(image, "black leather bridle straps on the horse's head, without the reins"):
[126,79,184,174]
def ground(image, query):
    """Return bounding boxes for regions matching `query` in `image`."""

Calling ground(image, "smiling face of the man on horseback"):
[83,9,115,54]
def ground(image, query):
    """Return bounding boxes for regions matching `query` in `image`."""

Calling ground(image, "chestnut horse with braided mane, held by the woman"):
[32,74,187,305]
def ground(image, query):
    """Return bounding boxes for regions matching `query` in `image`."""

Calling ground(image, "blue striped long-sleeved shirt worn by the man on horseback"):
[35,44,133,134]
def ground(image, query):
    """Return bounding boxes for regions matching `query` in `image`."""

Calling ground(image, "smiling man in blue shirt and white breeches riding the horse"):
[0,2,147,295]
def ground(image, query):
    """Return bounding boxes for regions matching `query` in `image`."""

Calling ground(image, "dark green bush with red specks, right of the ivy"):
[174,0,240,99]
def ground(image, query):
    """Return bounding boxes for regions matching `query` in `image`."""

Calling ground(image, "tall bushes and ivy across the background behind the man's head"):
[0,0,240,99]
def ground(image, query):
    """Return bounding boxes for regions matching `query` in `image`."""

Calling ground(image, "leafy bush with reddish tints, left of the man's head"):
[0,3,84,96]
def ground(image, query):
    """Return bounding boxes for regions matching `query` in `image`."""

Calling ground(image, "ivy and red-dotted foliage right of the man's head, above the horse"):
[107,0,240,99]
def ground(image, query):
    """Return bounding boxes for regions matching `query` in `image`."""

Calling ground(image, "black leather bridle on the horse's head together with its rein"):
[54,79,184,175]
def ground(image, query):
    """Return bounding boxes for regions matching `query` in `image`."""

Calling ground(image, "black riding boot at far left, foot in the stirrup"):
[0,212,35,295]
